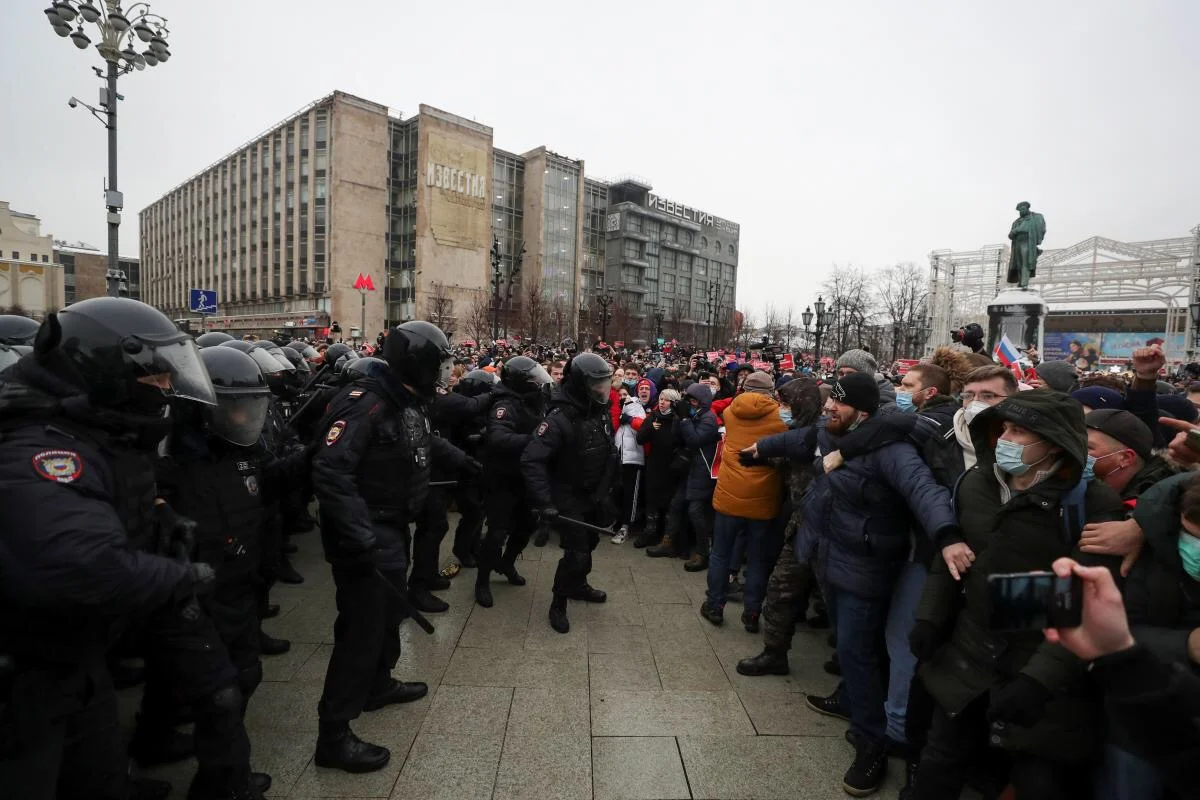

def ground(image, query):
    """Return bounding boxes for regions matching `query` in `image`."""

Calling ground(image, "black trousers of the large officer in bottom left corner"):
[0,654,127,800]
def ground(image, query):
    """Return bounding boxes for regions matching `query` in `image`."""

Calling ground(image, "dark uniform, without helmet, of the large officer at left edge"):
[0,371,191,800]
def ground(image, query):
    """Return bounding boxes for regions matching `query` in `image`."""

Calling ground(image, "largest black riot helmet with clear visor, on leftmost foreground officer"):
[34,297,216,416]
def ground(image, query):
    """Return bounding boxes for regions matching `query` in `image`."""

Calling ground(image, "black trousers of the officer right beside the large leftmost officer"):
[134,597,252,777]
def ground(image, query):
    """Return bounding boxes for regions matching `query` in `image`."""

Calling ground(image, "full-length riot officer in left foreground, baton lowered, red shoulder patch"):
[312,321,478,772]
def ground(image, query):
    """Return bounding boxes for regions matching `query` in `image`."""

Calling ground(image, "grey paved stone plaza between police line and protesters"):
[122,520,904,800]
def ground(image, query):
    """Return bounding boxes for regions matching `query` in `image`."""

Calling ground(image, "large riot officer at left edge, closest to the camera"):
[0,297,216,800]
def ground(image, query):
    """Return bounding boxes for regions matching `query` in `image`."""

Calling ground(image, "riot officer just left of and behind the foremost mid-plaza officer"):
[475,355,551,608]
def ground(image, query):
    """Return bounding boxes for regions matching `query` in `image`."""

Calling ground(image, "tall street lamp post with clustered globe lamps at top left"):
[46,0,170,297]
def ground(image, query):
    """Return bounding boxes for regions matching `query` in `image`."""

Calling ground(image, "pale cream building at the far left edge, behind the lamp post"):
[0,200,66,318]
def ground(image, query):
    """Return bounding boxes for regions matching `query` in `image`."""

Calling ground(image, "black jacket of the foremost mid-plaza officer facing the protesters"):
[521,387,618,515]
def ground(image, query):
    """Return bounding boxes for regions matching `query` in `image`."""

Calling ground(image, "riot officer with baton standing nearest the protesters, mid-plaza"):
[521,353,617,633]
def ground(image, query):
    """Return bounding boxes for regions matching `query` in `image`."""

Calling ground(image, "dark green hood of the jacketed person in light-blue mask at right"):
[971,389,1087,480]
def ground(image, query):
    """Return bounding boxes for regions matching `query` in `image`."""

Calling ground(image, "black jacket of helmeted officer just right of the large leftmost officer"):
[155,428,264,582]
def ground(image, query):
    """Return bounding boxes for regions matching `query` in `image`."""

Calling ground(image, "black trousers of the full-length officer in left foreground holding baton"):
[317,565,408,722]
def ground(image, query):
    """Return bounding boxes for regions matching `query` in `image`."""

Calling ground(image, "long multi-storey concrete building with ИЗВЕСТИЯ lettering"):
[140,92,736,341]
